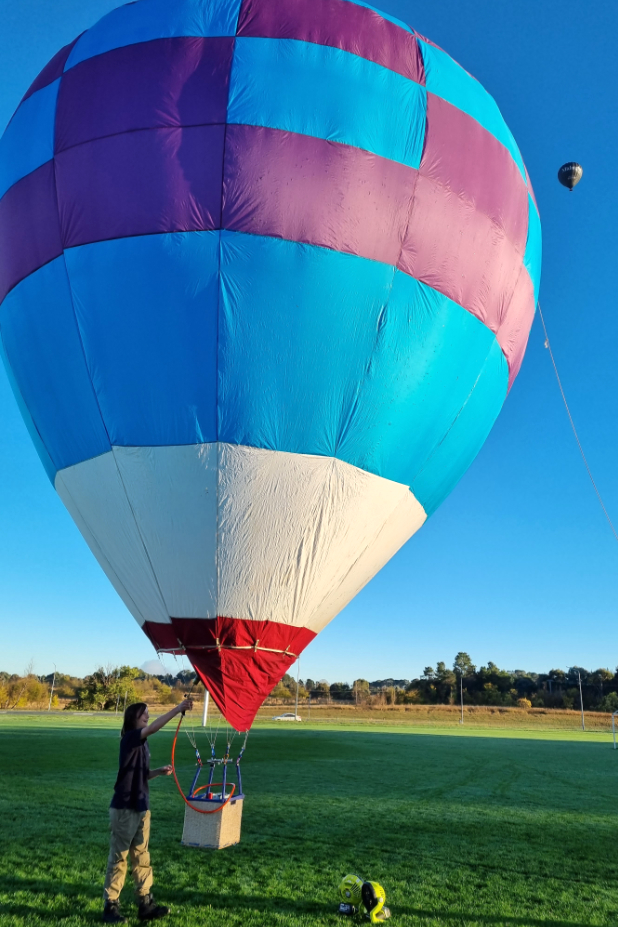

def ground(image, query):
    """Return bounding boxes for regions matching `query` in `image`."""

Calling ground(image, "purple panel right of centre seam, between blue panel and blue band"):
[223,125,417,265]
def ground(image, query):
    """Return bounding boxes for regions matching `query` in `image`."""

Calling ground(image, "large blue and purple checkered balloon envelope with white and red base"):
[0,0,541,730]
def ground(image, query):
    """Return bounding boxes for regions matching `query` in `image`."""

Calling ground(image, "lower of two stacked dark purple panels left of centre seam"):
[56,126,225,248]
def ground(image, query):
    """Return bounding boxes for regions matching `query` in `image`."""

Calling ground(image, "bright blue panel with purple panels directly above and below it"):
[228,38,427,168]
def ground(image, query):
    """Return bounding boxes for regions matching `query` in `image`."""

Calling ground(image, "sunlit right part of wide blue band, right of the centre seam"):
[219,232,508,510]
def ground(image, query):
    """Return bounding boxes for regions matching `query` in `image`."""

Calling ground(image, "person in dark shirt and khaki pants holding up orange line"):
[103,698,193,924]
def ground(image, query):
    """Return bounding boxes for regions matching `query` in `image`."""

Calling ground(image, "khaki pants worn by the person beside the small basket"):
[103,808,152,901]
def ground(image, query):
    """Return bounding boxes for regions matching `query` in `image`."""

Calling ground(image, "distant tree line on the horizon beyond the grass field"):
[0,651,618,712]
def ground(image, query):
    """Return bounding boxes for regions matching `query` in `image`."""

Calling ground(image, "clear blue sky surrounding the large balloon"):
[0,0,618,682]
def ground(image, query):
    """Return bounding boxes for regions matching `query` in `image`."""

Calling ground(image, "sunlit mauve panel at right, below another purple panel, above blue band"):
[398,173,523,376]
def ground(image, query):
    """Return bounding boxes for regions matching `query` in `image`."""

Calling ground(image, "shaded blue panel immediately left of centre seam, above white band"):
[66,231,219,446]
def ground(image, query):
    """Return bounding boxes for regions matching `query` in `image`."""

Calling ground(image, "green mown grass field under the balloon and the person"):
[0,714,618,927]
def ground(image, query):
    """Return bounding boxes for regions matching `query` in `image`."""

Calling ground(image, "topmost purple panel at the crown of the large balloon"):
[237,0,425,85]
